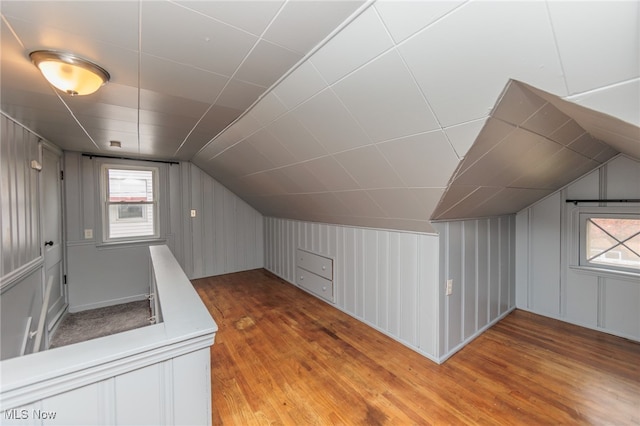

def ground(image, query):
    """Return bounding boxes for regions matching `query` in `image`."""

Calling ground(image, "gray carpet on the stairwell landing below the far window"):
[49,300,151,348]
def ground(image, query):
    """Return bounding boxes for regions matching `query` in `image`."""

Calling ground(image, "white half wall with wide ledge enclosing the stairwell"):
[0,246,218,424]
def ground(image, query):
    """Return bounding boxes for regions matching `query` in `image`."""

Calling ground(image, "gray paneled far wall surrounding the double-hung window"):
[64,152,264,311]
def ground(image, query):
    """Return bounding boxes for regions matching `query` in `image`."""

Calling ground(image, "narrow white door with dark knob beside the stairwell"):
[42,145,67,345]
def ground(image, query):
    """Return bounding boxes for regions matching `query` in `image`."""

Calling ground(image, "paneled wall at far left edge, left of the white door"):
[0,115,43,359]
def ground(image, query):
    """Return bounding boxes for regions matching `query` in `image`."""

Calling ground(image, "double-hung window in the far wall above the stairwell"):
[102,165,158,241]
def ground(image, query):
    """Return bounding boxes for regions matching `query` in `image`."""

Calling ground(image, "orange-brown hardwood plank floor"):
[193,270,640,425]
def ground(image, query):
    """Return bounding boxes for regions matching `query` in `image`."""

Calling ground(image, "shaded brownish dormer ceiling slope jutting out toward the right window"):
[432,82,620,220]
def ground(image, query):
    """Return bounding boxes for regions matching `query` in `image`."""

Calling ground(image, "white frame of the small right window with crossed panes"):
[573,207,640,277]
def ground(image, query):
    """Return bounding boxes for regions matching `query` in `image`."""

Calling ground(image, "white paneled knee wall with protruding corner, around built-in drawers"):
[265,216,515,362]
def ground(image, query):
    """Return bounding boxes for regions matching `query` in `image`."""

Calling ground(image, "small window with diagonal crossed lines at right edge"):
[580,213,640,273]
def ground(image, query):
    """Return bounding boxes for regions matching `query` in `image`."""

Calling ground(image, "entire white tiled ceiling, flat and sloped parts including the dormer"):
[0,0,640,232]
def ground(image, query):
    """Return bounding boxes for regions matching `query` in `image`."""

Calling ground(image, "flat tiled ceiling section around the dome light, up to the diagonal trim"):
[0,0,363,160]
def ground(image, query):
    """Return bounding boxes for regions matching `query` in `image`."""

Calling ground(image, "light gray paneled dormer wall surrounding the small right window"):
[516,155,640,340]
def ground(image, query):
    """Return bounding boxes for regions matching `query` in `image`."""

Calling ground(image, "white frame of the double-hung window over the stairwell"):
[100,163,160,244]
